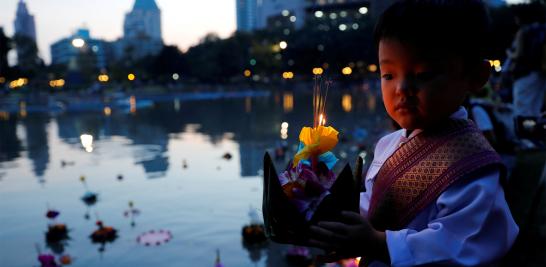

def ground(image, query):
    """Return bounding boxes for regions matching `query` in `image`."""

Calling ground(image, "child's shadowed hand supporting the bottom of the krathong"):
[308,211,390,263]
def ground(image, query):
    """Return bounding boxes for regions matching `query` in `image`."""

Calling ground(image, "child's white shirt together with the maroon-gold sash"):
[360,107,518,266]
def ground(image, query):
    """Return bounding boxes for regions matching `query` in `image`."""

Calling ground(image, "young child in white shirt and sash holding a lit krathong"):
[309,0,518,266]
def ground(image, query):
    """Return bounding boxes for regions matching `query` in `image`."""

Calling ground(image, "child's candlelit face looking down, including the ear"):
[379,39,471,130]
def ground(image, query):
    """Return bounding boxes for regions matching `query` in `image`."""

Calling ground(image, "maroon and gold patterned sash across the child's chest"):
[368,120,504,231]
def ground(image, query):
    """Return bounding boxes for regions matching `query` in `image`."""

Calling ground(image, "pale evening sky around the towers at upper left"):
[0,0,236,64]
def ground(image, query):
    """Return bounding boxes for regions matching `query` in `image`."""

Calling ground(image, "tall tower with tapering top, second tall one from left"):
[121,0,163,59]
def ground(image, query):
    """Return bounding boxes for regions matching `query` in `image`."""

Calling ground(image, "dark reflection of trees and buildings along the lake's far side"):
[0,89,383,178]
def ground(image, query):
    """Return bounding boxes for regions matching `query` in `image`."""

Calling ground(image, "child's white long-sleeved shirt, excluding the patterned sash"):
[360,107,519,266]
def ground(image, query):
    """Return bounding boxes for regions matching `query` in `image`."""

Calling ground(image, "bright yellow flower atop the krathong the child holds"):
[294,126,338,166]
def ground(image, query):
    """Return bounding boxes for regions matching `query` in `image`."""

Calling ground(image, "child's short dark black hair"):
[374,0,490,67]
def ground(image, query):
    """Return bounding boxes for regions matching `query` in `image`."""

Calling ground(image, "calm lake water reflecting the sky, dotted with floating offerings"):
[0,85,389,267]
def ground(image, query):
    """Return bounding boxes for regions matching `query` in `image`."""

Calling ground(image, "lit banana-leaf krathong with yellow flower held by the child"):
[263,78,362,244]
